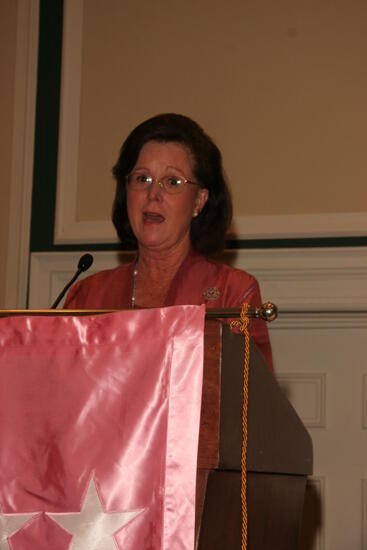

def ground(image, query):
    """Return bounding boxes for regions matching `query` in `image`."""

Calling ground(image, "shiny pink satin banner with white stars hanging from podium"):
[0,306,205,550]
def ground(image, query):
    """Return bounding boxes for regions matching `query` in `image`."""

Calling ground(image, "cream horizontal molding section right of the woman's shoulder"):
[223,247,367,314]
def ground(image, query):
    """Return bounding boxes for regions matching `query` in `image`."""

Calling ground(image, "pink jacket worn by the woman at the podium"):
[64,251,273,369]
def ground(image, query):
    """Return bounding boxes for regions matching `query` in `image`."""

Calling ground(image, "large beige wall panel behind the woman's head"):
[77,0,367,224]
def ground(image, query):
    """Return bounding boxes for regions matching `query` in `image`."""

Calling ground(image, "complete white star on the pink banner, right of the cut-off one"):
[47,478,142,550]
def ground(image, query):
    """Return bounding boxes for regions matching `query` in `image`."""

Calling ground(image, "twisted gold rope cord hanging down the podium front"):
[230,304,250,550]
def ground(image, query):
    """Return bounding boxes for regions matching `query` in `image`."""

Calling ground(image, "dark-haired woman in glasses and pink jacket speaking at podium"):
[64,114,272,368]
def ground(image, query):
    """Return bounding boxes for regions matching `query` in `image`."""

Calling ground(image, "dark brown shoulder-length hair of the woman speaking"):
[112,114,232,255]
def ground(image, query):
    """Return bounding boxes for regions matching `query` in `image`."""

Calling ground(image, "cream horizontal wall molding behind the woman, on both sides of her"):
[30,248,367,322]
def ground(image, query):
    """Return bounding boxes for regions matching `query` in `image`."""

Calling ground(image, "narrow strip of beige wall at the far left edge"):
[0,0,17,307]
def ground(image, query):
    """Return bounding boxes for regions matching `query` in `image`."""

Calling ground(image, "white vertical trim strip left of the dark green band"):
[5,0,39,308]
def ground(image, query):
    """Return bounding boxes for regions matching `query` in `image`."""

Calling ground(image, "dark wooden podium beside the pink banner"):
[196,321,312,550]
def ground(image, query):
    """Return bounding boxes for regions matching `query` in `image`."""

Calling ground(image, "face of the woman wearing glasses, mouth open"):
[127,141,208,253]
